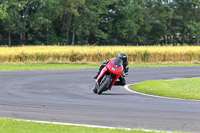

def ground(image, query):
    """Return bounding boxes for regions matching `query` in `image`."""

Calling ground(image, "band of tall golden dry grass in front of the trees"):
[0,46,200,64]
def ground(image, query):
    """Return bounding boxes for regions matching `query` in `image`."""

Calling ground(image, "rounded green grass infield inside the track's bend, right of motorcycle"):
[131,78,200,100]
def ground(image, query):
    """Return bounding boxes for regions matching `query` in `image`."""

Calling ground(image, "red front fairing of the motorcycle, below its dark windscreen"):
[106,59,123,76]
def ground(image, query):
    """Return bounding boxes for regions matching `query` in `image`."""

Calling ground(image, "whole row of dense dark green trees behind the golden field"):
[0,0,200,46]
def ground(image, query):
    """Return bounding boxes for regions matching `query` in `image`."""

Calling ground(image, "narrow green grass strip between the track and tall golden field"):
[0,64,200,71]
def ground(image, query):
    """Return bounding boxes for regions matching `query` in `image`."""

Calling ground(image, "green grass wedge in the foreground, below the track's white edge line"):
[0,118,170,133]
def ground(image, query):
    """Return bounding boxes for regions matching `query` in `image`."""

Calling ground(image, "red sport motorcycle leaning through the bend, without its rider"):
[93,57,123,94]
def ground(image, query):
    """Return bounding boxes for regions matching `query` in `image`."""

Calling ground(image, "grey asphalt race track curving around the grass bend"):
[0,67,200,132]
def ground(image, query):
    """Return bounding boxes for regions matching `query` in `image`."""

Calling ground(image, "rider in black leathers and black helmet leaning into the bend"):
[94,53,129,85]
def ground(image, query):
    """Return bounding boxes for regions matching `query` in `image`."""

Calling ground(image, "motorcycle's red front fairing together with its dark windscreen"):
[106,57,123,76]
